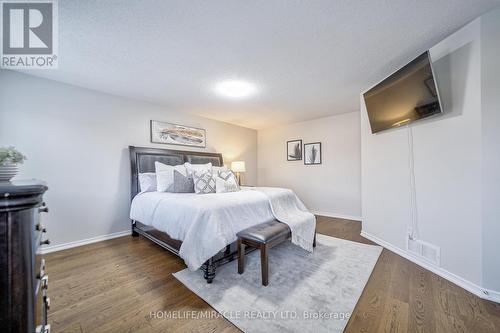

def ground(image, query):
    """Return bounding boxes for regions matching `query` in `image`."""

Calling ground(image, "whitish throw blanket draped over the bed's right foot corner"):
[255,187,316,252]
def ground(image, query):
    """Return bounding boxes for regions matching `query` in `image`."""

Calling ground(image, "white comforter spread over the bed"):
[130,188,315,270]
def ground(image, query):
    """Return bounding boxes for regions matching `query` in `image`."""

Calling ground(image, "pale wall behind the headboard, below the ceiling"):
[0,70,257,248]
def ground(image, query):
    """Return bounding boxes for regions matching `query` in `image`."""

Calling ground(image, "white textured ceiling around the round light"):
[14,0,500,129]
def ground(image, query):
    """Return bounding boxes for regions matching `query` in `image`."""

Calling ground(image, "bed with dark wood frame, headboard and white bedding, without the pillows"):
[129,146,316,283]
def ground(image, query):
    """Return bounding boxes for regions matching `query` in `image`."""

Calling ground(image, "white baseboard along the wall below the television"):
[361,230,500,303]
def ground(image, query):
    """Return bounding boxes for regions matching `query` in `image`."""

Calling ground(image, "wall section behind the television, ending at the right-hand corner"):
[361,20,481,284]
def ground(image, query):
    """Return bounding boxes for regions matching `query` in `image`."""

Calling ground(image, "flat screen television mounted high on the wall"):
[363,51,441,133]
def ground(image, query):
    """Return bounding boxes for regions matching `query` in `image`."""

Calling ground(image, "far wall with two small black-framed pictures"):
[258,112,361,219]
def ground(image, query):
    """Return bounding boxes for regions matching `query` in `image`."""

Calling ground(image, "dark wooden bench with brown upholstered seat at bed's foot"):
[236,220,316,286]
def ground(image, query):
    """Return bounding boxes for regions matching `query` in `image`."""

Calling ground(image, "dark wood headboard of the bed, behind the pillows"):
[128,146,224,200]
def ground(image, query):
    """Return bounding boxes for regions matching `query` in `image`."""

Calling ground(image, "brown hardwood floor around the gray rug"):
[46,217,500,333]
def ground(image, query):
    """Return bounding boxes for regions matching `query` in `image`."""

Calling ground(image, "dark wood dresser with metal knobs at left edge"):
[0,180,50,333]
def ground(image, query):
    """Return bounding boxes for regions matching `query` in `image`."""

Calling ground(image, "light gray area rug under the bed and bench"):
[174,234,382,333]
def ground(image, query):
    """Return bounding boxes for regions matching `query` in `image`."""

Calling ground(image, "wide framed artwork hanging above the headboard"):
[150,120,207,148]
